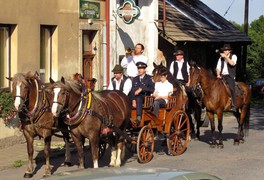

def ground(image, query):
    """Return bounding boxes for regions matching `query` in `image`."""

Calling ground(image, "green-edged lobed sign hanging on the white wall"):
[117,0,140,24]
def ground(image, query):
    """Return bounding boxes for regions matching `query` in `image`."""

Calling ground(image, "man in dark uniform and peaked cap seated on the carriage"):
[131,62,155,126]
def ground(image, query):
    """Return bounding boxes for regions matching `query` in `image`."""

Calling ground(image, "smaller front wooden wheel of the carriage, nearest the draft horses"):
[137,126,154,163]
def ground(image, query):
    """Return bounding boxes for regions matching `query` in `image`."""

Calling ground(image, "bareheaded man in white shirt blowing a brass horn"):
[121,43,148,79]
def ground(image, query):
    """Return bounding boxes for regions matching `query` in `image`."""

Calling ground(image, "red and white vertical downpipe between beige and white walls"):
[103,0,110,89]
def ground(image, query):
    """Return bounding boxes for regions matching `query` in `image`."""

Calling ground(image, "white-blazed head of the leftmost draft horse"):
[6,72,39,112]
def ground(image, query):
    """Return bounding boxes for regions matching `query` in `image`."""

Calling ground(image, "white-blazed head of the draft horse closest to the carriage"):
[50,77,82,117]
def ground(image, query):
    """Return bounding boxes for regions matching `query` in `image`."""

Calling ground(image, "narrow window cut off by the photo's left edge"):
[0,24,11,88]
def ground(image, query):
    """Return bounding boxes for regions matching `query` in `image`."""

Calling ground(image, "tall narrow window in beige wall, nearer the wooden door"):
[40,25,56,82]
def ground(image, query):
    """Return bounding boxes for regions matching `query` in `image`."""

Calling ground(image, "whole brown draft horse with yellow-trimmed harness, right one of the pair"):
[50,77,131,169]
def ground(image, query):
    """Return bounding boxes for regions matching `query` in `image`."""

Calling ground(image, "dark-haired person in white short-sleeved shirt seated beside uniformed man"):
[153,69,173,117]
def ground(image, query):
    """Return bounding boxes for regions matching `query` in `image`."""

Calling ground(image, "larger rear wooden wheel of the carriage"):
[167,110,190,156]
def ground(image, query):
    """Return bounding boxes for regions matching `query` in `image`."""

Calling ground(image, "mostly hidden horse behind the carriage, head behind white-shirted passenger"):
[152,63,203,139]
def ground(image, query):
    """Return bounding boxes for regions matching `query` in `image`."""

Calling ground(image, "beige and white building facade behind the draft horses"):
[0,0,158,89]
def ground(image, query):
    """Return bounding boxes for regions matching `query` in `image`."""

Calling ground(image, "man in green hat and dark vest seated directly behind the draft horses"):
[107,64,132,96]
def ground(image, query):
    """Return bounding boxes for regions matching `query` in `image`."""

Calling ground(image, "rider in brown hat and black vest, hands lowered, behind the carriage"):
[170,50,190,87]
